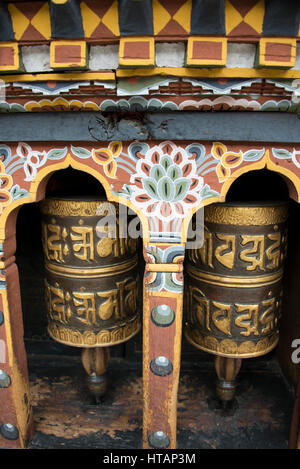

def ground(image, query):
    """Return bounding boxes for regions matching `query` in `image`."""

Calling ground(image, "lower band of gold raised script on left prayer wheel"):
[45,278,138,326]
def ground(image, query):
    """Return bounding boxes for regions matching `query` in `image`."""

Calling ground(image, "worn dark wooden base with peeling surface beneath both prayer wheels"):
[22,352,293,450]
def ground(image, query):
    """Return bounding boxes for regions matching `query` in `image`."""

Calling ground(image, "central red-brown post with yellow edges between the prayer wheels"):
[143,243,184,449]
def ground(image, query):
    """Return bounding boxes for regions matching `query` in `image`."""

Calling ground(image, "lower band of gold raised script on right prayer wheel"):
[188,286,281,338]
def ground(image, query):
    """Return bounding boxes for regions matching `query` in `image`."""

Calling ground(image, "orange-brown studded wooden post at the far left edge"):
[0,235,33,449]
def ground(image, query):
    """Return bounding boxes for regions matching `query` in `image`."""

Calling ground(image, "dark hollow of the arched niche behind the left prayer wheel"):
[15,167,143,357]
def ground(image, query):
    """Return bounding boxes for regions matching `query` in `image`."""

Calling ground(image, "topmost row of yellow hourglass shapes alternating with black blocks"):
[0,0,300,43]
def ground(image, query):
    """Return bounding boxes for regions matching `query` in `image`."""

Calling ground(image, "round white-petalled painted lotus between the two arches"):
[130,142,203,221]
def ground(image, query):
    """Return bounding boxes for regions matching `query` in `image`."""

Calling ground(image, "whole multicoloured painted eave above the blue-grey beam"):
[0,0,300,112]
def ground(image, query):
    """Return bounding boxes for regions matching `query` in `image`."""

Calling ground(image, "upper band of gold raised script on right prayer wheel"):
[189,231,287,271]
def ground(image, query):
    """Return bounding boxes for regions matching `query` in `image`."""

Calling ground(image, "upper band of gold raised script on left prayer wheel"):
[42,219,136,264]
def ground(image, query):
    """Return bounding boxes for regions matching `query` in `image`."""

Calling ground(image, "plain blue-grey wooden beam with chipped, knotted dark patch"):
[0,111,300,143]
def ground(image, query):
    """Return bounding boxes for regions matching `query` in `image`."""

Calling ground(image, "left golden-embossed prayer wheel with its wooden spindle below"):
[40,198,140,401]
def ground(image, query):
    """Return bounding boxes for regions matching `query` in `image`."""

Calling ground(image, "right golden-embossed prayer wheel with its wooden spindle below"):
[185,203,288,402]
